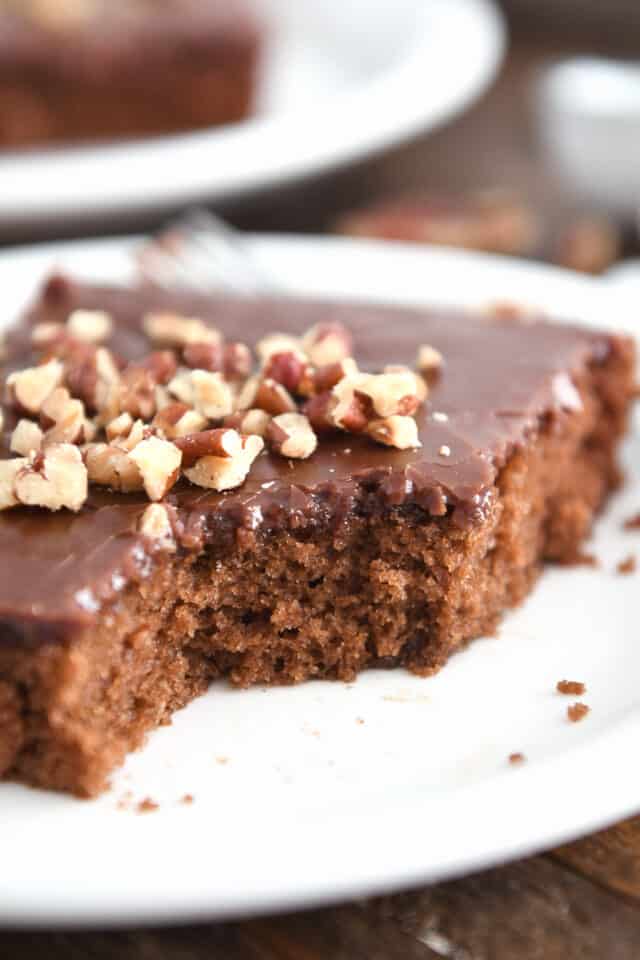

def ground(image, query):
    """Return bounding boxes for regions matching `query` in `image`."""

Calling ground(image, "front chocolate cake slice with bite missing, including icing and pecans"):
[0,277,634,796]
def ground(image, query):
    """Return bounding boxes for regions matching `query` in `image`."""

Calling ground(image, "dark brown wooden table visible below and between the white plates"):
[5,11,640,960]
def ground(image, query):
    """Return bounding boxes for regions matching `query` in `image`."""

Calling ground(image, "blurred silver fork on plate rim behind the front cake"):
[136,210,277,297]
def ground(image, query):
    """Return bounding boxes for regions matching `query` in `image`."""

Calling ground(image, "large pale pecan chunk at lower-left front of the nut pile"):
[14,443,88,512]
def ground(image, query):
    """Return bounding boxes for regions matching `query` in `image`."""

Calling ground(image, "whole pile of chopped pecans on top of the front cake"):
[0,298,436,510]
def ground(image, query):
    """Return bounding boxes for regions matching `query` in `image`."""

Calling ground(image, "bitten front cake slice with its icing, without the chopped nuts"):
[0,278,633,796]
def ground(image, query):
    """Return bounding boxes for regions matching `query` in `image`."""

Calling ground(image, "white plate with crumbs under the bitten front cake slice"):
[0,237,640,925]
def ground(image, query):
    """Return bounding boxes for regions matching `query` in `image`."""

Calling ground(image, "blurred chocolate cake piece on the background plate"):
[0,0,261,147]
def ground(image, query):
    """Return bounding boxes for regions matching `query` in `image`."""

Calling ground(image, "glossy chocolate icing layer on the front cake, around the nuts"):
[0,280,611,642]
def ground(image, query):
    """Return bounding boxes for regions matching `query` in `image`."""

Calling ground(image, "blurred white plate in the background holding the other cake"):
[0,0,504,229]
